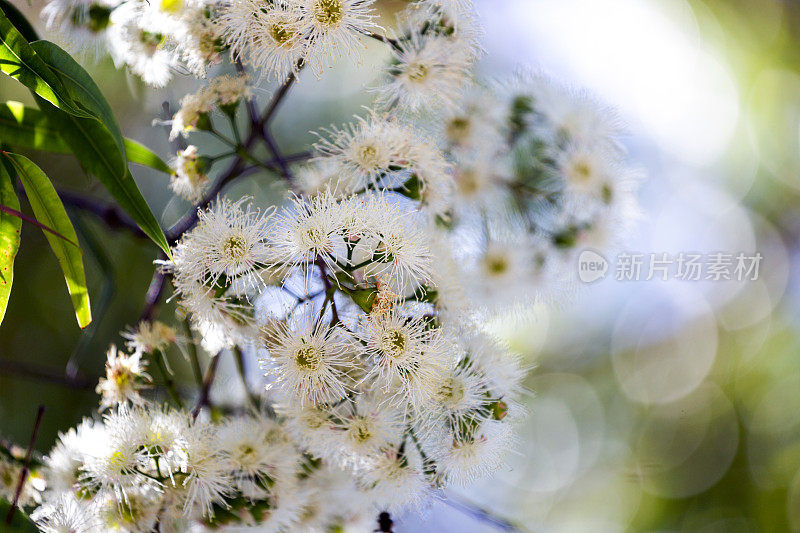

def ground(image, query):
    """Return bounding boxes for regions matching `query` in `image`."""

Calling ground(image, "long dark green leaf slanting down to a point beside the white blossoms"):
[36,98,171,256]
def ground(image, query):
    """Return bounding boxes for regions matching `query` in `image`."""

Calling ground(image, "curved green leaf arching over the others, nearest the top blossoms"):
[31,41,128,172]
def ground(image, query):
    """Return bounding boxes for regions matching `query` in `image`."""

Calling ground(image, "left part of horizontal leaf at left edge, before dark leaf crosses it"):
[0,101,71,153]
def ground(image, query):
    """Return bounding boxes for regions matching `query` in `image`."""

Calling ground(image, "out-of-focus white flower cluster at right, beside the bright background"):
[440,74,639,308]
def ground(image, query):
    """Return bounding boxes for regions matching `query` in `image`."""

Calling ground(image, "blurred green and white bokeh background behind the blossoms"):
[0,0,800,532]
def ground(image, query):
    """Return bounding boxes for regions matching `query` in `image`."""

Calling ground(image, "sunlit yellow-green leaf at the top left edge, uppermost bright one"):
[0,7,91,117]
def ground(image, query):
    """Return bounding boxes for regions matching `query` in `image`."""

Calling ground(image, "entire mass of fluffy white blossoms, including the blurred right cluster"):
[14,0,638,531]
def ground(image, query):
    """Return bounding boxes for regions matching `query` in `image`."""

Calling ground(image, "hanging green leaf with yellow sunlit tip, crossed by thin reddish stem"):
[3,150,91,328]
